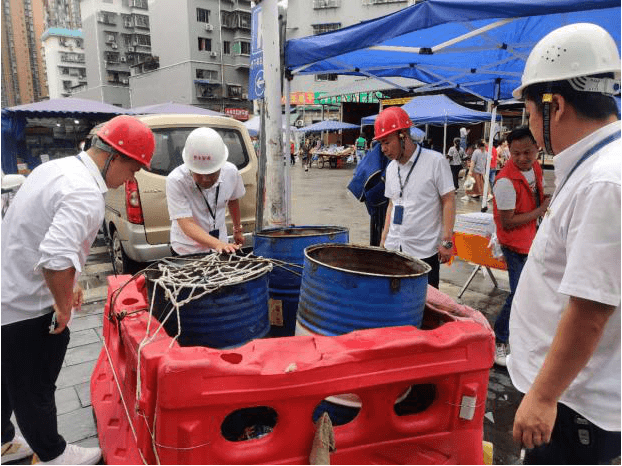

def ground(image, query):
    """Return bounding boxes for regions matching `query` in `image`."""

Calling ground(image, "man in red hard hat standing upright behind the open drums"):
[374,107,456,288]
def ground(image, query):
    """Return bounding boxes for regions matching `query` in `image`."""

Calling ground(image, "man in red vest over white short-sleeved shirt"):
[493,126,550,366]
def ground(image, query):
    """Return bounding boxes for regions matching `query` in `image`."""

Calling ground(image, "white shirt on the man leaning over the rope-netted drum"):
[166,162,246,254]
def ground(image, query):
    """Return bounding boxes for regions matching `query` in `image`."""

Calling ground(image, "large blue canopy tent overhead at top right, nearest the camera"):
[285,0,620,210]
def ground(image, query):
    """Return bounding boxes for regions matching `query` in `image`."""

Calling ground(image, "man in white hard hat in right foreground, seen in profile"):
[507,23,622,464]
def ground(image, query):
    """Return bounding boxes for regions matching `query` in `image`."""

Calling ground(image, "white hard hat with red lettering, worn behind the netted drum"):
[181,128,229,175]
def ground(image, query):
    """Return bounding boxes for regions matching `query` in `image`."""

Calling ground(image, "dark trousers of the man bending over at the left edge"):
[2,312,69,461]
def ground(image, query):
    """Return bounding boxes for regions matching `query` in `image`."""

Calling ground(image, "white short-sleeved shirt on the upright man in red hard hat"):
[384,148,455,259]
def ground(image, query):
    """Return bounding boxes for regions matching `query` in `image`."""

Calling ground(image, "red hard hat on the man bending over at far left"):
[97,115,155,168]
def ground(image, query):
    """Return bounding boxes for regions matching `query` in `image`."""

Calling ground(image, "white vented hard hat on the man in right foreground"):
[512,23,620,99]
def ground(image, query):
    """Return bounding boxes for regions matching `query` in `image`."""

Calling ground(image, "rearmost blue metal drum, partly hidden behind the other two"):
[253,226,349,337]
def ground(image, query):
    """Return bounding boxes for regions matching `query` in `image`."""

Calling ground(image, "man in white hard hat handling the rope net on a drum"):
[166,128,246,255]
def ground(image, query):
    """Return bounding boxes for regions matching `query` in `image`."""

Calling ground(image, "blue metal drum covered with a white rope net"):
[147,255,270,349]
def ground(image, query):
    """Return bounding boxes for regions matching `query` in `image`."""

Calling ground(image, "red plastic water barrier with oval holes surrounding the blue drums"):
[91,276,494,464]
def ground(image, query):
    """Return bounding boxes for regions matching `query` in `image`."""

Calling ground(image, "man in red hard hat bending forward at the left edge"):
[2,116,155,464]
